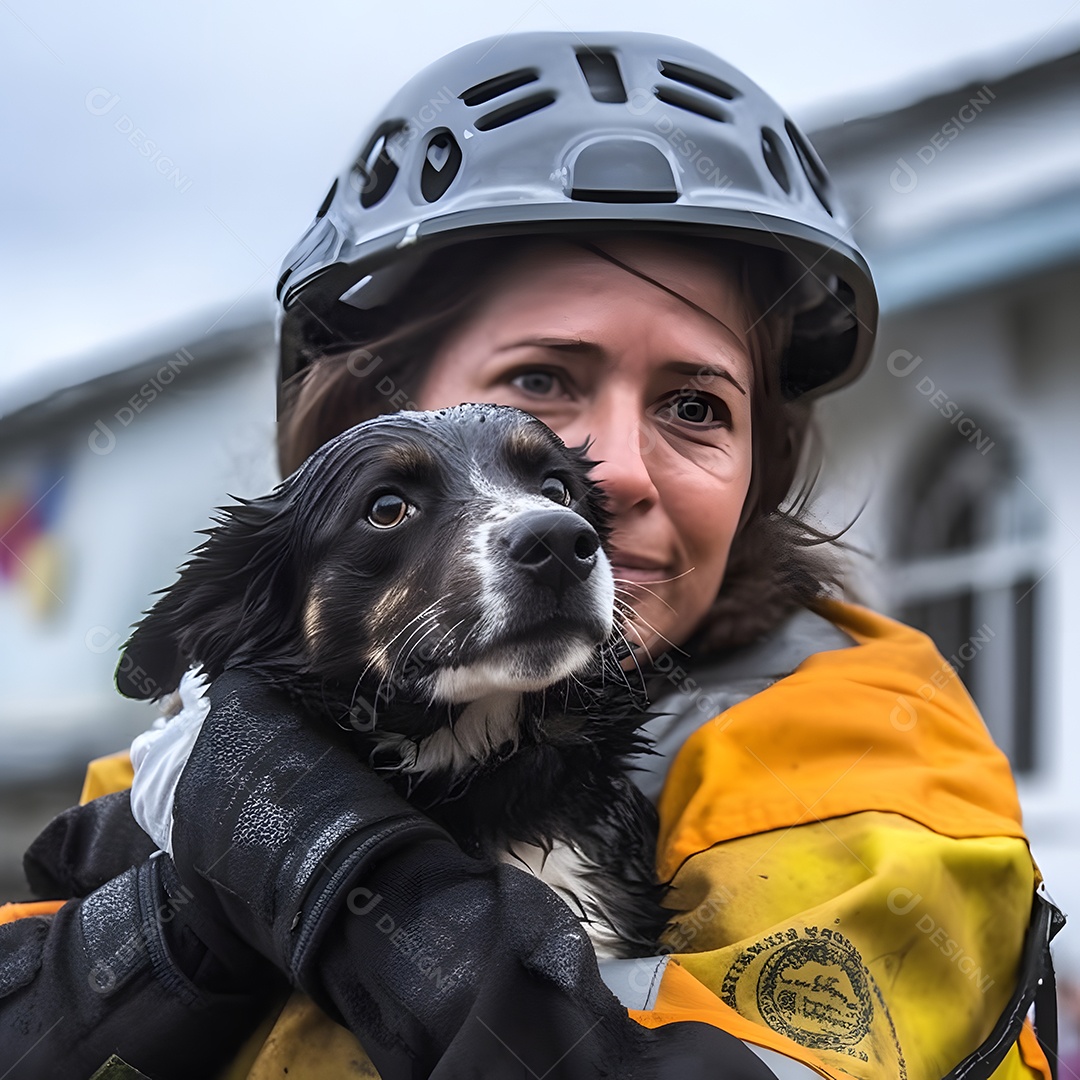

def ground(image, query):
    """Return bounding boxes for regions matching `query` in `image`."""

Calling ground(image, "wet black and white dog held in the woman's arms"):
[117,405,671,957]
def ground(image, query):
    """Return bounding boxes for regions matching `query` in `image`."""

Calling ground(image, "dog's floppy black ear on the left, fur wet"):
[116,485,296,700]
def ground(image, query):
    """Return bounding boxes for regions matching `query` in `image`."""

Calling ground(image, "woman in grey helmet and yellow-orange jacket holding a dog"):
[0,25,1049,1080]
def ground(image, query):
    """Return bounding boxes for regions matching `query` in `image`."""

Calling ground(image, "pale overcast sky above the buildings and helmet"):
[0,0,1080,401]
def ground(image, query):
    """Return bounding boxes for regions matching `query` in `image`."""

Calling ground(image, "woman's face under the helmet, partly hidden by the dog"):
[417,235,753,658]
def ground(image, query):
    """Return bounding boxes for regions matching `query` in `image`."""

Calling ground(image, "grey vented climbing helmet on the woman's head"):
[278,32,878,399]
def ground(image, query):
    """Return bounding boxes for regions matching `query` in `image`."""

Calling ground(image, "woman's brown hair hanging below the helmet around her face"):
[278,233,850,656]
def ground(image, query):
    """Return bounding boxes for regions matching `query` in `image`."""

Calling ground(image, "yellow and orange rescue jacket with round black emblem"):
[4,600,1051,1080]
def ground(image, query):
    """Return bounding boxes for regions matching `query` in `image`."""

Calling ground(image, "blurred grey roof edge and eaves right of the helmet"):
[810,42,1080,311]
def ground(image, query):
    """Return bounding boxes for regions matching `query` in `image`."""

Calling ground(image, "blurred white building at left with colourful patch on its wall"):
[0,298,276,899]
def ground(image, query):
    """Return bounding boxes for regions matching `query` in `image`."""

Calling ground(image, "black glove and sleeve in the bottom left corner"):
[0,855,289,1080]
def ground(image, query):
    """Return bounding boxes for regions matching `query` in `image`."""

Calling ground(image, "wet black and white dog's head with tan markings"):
[117,405,615,717]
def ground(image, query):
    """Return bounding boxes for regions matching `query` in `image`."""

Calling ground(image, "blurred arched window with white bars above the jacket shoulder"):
[889,431,1048,773]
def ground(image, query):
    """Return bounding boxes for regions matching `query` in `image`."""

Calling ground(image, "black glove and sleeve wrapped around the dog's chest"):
[173,671,772,1080]
